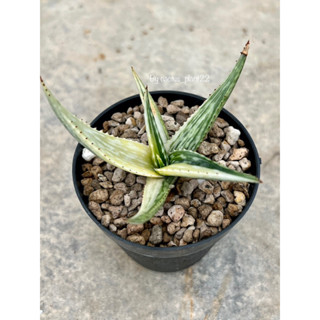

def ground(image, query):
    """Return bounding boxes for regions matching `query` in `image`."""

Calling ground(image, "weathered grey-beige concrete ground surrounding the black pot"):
[40,0,279,320]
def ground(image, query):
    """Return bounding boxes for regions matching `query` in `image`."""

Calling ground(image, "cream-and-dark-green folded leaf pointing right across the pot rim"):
[155,150,261,183]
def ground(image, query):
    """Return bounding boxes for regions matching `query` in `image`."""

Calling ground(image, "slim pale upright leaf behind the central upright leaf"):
[131,67,169,143]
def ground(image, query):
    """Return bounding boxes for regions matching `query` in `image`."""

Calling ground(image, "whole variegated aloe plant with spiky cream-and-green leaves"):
[41,42,259,223]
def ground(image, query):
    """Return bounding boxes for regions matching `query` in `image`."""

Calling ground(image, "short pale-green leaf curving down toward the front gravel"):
[128,177,177,223]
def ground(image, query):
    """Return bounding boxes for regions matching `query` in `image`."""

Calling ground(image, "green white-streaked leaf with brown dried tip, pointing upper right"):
[166,41,249,152]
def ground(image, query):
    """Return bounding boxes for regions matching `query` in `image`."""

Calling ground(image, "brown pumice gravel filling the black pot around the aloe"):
[81,97,251,247]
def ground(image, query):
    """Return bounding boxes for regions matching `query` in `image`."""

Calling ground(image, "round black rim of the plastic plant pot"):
[72,90,261,252]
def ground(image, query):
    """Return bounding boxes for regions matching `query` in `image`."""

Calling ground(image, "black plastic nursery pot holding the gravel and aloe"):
[72,91,260,272]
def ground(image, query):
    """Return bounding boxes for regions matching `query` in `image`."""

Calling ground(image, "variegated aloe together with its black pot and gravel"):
[41,42,260,271]
